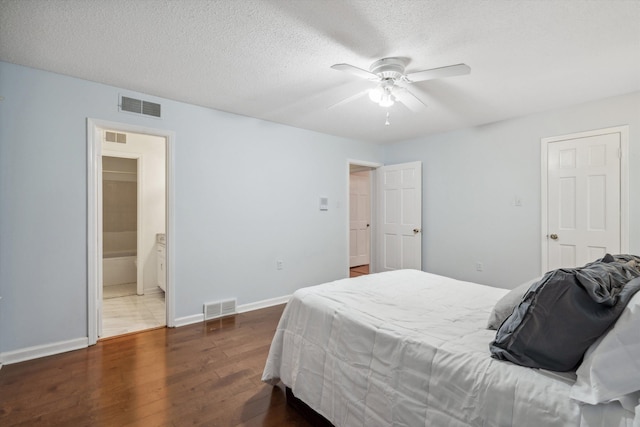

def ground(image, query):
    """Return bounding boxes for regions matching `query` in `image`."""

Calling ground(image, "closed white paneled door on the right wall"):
[543,132,621,271]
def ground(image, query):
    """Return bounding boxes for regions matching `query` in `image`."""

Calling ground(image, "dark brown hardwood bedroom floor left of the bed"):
[0,305,309,427]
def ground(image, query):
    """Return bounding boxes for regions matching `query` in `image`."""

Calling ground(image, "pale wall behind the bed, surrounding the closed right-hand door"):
[385,92,640,288]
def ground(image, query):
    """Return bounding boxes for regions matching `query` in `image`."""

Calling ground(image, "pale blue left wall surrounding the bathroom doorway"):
[0,62,382,357]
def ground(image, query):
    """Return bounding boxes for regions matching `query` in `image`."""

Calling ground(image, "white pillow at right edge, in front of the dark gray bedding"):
[569,292,640,405]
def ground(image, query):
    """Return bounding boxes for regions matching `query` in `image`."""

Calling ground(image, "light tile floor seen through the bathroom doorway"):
[100,291,167,338]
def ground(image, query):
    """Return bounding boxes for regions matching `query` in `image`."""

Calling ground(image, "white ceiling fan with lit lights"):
[329,58,471,112]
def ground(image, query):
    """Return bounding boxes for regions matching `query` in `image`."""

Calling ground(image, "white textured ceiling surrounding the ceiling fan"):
[0,0,640,142]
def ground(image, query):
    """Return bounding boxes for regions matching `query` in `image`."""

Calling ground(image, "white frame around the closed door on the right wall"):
[540,125,629,274]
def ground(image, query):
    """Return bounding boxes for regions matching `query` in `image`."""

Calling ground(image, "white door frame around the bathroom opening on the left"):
[87,118,176,345]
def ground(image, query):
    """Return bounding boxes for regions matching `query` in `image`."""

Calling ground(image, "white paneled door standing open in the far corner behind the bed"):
[376,162,422,271]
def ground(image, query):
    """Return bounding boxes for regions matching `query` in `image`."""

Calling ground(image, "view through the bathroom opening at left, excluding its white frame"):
[98,129,167,338]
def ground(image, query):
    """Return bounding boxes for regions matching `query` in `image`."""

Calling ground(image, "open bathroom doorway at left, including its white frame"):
[87,119,175,345]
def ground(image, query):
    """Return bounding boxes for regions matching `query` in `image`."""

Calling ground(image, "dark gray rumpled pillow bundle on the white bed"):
[489,254,640,371]
